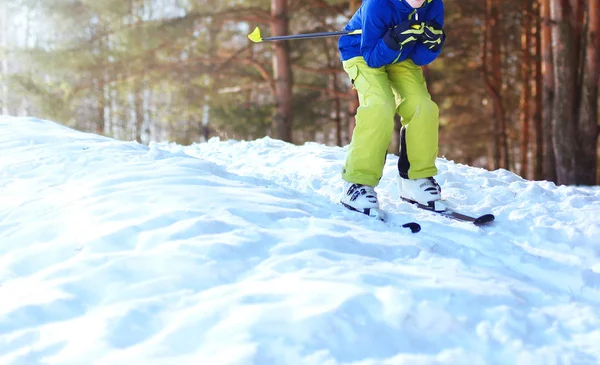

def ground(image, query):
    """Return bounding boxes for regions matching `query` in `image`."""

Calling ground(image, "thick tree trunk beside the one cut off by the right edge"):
[550,0,577,185]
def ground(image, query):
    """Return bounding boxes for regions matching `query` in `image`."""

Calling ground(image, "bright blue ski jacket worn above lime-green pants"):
[338,0,444,68]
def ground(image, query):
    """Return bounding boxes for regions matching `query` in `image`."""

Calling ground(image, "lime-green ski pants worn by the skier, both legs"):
[342,57,439,186]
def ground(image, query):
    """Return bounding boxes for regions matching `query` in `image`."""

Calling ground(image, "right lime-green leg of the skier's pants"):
[386,60,439,179]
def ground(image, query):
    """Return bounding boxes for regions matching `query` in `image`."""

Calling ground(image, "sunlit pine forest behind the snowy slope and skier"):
[0,0,600,185]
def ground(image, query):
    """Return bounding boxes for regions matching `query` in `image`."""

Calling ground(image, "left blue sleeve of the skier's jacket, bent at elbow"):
[360,0,411,68]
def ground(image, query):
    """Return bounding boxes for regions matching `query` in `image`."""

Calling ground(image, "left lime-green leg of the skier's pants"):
[342,57,396,186]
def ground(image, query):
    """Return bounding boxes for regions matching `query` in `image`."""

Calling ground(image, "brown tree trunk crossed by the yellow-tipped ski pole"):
[271,0,293,142]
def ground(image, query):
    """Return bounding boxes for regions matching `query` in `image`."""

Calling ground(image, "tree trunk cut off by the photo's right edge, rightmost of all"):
[577,1,600,185]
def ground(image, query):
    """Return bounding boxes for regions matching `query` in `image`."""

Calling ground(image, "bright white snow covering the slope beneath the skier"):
[0,117,600,365]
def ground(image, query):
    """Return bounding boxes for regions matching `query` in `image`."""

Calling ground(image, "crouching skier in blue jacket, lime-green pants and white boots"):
[338,0,446,216]
